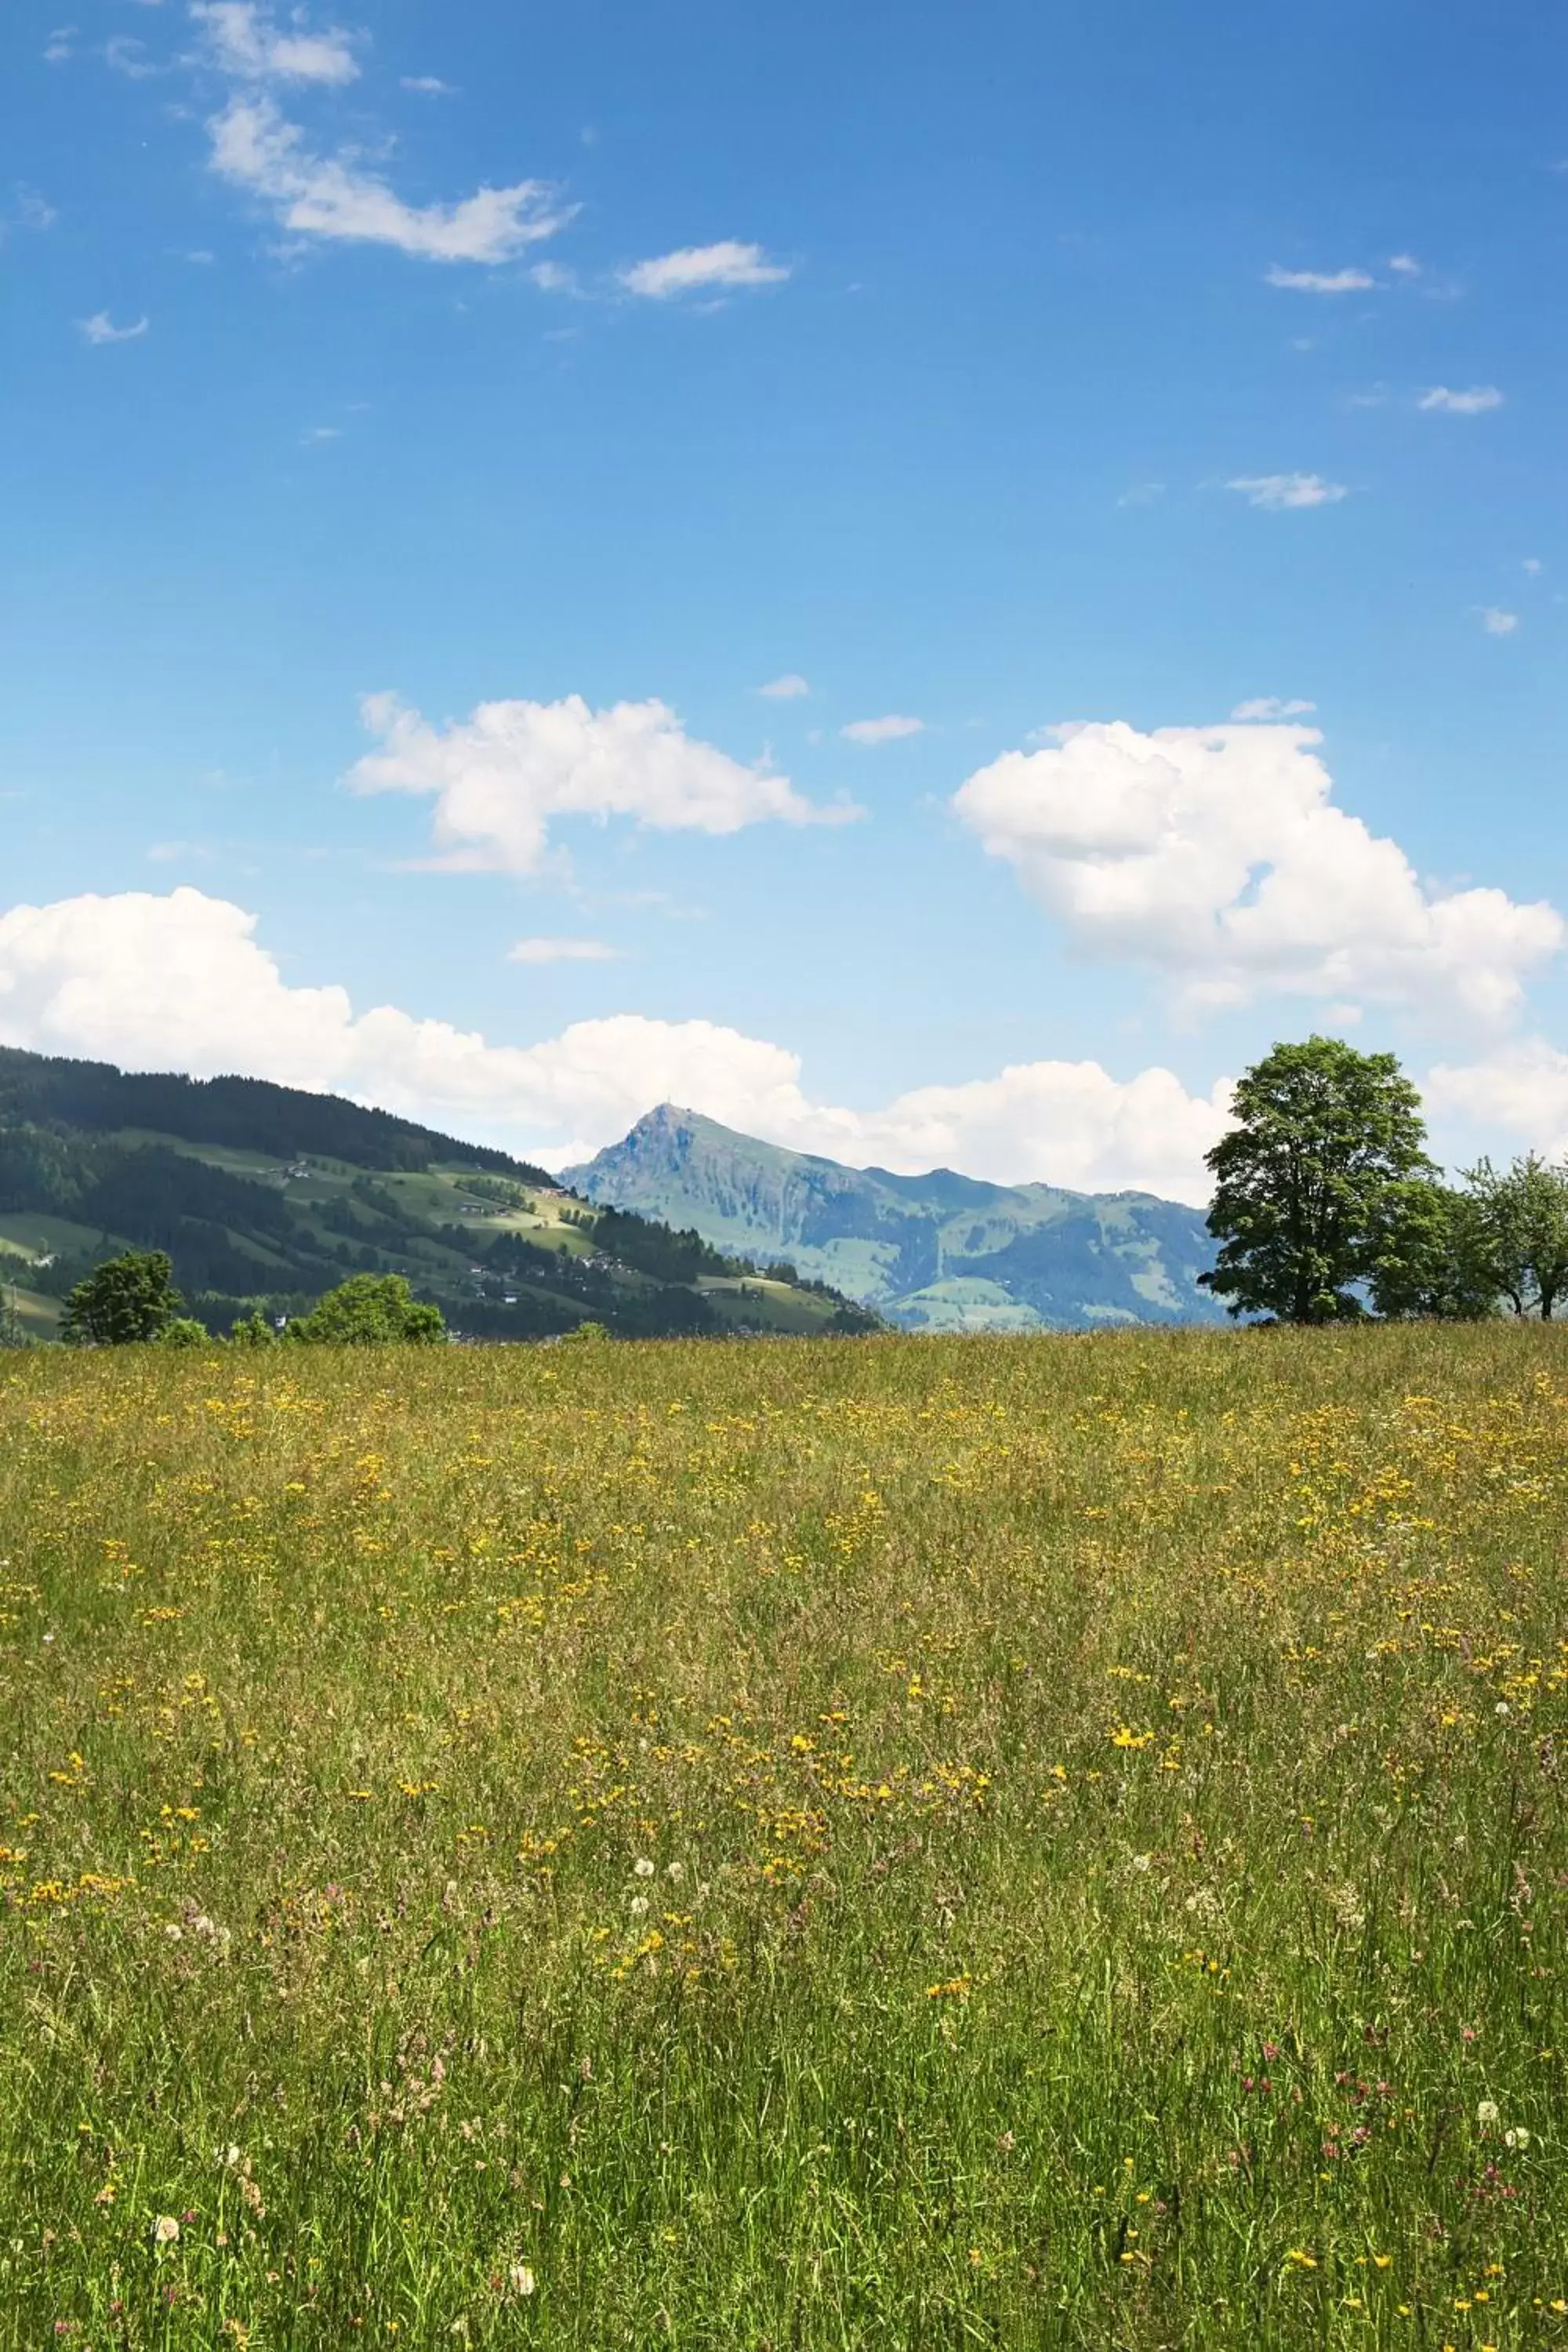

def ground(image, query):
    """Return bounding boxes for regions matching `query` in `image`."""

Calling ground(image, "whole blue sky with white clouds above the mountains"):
[0,0,1568,1197]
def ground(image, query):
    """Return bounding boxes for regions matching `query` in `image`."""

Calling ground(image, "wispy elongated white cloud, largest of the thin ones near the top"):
[207,96,572,261]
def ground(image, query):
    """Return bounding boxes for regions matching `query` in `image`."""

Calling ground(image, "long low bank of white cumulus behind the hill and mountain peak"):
[0,889,1229,1200]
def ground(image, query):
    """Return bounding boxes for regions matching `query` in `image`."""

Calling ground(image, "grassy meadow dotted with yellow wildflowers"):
[0,1327,1568,2352]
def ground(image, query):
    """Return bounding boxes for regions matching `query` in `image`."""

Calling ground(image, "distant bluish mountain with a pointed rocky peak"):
[562,1103,1225,1331]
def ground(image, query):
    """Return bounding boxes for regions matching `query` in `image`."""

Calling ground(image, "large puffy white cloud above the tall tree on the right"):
[954,720,1568,1023]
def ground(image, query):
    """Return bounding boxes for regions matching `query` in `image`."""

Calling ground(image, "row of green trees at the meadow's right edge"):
[1199,1037,1568,1324]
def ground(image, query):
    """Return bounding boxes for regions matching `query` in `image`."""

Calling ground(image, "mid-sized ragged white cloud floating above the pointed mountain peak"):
[348,694,858,875]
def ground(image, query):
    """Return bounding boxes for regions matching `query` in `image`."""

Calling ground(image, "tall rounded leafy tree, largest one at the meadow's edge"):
[1199,1037,1436,1324]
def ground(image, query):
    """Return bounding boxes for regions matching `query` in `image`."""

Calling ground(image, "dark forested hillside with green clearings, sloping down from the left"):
[0,1047,877,1338]
